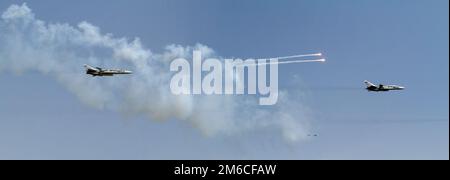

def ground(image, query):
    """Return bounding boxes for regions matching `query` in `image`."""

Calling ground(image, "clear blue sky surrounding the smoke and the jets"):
[0,0,449,159]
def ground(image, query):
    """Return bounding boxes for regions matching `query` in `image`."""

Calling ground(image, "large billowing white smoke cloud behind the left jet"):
[0,4,309,142]
